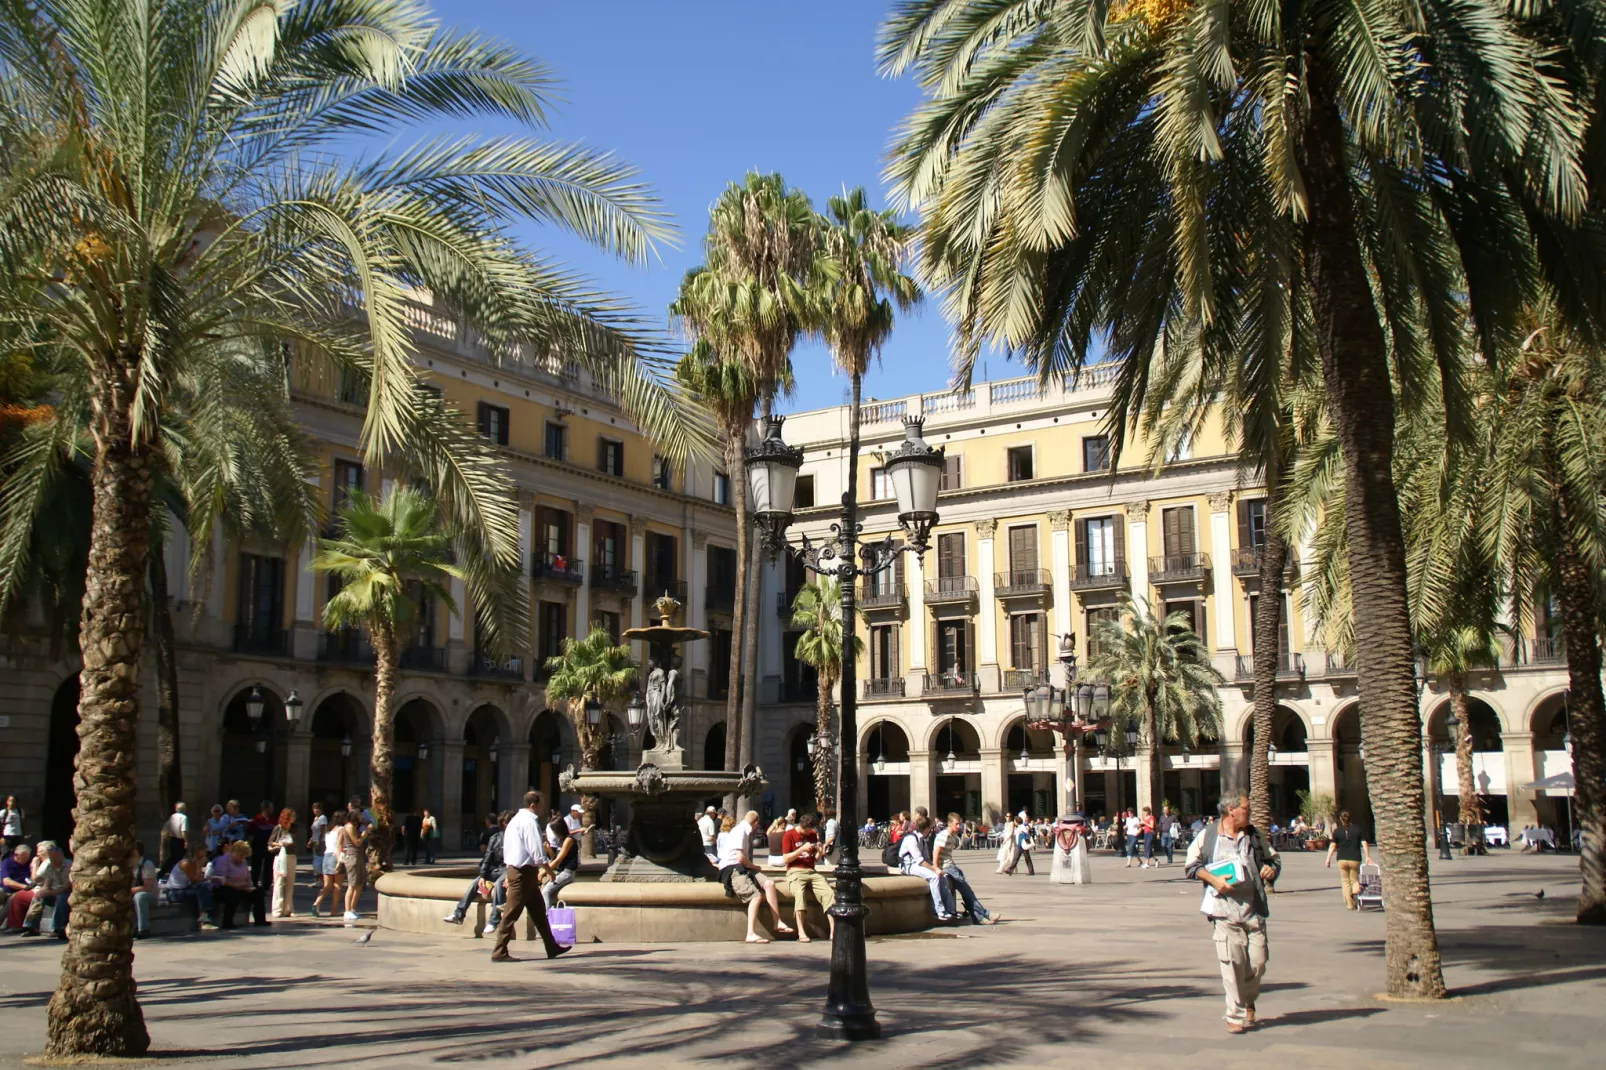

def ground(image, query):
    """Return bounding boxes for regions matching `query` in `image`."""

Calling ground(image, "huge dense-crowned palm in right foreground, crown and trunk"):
[880,0,1601,998]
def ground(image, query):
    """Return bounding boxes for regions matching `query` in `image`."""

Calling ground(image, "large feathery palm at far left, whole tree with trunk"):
[0,0,680,1057]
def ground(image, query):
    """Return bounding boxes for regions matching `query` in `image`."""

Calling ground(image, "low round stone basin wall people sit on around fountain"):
[374,866,936,943]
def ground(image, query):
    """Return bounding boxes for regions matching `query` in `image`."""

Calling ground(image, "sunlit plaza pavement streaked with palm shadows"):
[0,852,1606,1070]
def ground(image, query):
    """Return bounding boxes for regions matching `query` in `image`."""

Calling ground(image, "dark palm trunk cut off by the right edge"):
[1551,464,1606,925]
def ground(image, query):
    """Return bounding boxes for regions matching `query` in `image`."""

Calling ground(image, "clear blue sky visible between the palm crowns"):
[437,0,1020,411]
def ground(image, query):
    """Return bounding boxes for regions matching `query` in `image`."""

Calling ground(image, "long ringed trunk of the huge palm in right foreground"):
[1302,55,1445,998]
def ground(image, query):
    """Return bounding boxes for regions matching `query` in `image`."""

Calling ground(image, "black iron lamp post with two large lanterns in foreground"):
[744,408,943,1039]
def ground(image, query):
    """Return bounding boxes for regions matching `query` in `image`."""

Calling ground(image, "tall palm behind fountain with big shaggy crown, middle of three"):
[671,172,822,790]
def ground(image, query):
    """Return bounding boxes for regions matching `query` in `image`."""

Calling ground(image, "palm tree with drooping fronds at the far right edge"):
[1478,304,1606,925]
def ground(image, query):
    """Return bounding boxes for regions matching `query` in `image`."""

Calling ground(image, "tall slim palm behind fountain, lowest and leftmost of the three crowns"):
[670,294,758,784]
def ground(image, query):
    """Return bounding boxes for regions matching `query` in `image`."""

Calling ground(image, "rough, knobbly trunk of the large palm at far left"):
[45,364,151,1059]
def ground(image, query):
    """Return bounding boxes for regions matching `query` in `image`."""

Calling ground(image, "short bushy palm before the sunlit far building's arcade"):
[1086,594,1224,807]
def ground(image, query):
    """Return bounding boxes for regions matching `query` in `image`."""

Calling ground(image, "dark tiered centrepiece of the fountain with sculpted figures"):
[559,594,768,884]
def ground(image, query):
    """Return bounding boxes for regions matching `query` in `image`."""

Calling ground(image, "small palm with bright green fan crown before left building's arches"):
[312,487,469,877]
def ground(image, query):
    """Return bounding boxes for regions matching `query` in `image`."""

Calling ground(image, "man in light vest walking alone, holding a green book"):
[1184,794,1283,1033]
